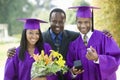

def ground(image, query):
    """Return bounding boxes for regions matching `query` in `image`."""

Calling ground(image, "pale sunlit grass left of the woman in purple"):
[0,35,20,80]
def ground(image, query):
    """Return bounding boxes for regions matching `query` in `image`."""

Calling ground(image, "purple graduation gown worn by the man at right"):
[67,30,120,80]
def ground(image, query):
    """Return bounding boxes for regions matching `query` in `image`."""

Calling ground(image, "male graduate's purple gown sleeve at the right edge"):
[99,37,120,80]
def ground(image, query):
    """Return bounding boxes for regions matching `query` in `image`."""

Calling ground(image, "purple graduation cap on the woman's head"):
[17,18,47,30]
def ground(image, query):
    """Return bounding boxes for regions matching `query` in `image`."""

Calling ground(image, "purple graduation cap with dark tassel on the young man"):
[69,5,99,31]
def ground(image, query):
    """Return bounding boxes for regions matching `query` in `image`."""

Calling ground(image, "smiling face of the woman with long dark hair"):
[26,29,40,46]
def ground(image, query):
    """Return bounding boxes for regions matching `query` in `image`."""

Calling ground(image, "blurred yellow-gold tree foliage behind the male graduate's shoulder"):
[93,0,120,45]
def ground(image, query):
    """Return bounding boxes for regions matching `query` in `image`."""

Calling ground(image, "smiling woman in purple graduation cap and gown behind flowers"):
[4,19,56,80]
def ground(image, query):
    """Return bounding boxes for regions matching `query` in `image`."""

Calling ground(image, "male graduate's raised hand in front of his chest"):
[86,46,98,61]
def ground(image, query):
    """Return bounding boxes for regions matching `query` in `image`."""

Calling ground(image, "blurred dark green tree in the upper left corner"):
[0,0,32,35]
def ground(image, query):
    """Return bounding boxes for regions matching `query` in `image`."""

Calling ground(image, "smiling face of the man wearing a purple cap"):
[77,18,92,34]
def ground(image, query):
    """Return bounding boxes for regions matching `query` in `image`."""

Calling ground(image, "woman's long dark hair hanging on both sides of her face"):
[19,29,44,60]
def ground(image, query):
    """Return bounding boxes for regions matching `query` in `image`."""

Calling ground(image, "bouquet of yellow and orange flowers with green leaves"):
[31,50,68,78]
